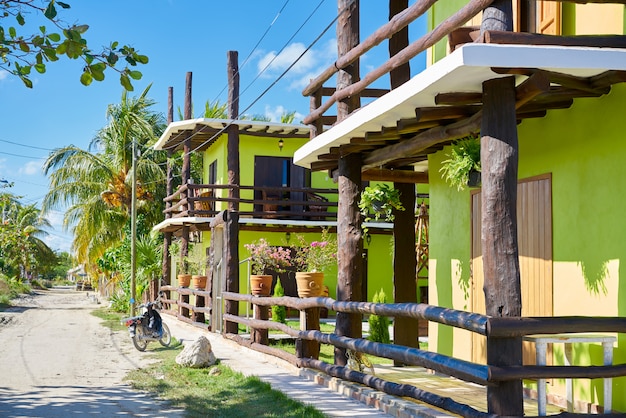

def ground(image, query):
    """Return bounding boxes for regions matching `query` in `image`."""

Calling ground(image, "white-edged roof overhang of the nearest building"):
[294,44,626,168]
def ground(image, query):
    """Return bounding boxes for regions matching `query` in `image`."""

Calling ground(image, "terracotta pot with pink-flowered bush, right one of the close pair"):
[292,229,337,298]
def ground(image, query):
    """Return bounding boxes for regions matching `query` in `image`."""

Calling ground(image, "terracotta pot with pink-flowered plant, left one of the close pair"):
[244,238,291,296]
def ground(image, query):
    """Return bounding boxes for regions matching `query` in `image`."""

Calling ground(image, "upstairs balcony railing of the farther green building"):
[164,184,337,221]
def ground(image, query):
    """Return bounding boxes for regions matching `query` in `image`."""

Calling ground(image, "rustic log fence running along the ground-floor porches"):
[156,286,626,418]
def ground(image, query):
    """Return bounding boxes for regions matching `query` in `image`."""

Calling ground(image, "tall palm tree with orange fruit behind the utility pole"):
[42,86,165,265]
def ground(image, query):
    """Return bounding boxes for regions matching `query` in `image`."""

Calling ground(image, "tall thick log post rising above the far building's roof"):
[224,51,239,334]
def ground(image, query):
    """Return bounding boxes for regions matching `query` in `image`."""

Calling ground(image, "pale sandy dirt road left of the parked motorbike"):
[0,289,182,418]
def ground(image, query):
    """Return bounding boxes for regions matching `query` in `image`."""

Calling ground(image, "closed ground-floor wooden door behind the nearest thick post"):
[471,175,553,364]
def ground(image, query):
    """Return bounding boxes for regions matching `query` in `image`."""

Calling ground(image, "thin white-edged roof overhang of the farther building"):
[154,118,310,150]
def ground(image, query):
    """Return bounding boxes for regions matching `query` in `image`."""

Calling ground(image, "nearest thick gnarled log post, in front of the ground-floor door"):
[480,77,524,416]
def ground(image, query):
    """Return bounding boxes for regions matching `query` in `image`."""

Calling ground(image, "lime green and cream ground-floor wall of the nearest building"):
[429,85,626,411]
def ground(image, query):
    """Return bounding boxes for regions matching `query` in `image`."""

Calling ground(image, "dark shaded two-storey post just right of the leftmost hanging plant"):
[388,0,419,366]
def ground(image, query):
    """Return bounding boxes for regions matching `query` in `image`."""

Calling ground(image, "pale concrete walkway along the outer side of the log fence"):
[163,315,450,418]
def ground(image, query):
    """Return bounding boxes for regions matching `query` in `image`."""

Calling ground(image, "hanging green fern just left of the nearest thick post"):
[439,134,480,191]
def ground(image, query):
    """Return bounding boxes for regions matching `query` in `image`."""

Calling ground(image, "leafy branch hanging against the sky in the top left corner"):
[0,0,148,91]
